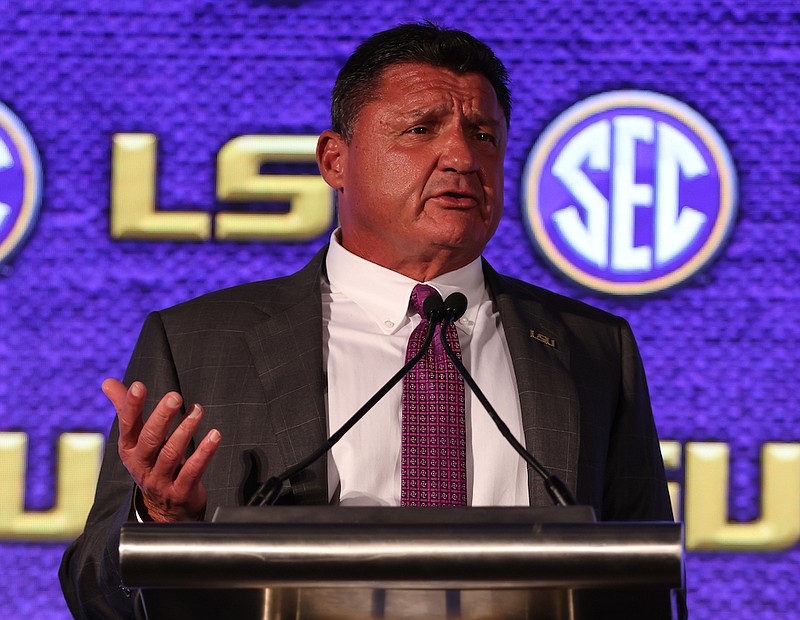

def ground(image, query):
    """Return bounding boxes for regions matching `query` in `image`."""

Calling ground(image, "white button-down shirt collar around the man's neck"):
[325,229,487,334]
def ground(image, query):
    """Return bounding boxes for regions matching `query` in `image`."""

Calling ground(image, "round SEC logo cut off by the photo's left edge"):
[0,103,42,265]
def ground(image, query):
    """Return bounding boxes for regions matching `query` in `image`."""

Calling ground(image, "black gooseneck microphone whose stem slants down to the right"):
[439,293,578,506]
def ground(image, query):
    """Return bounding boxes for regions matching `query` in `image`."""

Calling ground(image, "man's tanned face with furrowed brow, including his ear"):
[318,63,507,279]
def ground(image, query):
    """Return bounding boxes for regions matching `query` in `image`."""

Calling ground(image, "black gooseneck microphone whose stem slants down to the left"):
[247,291,446,506]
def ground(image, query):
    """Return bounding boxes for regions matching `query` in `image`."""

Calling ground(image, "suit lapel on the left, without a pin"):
[245,246,328,504]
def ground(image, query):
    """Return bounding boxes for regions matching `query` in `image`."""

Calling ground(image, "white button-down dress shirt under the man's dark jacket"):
[322,231,529,506]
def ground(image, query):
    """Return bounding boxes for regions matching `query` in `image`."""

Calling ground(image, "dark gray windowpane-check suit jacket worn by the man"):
[59,248,672,618]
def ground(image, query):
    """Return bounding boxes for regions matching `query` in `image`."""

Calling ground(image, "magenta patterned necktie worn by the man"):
[400,284,467,506]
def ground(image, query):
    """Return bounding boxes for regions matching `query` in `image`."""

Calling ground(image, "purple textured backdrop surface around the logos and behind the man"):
[0,0,800,619]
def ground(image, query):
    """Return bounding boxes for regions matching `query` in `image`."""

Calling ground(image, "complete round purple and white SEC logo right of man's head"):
[523,91,737,295]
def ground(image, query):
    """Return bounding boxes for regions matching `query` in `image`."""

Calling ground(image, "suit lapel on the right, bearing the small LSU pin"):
[484,263,580,506]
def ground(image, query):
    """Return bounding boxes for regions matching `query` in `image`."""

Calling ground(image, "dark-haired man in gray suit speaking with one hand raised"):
[61,24,672,617]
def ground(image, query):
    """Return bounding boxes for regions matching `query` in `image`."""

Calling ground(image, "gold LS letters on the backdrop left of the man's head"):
[111,133,334,241]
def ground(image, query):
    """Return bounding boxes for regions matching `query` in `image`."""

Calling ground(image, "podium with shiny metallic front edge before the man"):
[120,506,683,620]
